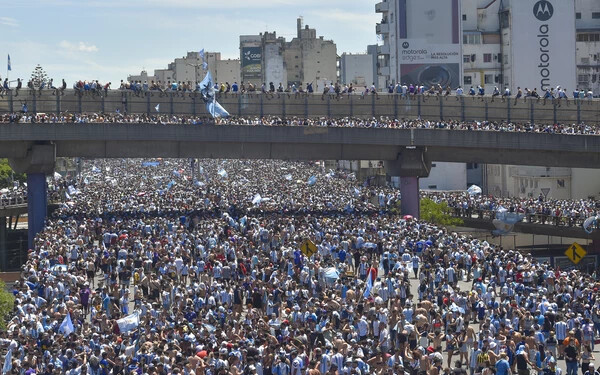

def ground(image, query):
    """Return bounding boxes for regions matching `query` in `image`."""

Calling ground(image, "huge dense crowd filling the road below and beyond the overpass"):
[0,160,600,375]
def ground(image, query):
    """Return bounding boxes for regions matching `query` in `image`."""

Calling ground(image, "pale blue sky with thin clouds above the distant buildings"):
[0,0,381,88]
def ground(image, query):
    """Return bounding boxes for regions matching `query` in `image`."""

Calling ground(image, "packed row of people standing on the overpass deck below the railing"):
[0,111,600,135]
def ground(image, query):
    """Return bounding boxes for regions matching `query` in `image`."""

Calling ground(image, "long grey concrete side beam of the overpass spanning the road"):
[0,123,600,170]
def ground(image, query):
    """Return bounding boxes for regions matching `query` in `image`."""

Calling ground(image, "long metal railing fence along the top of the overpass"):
[0,90,600,124]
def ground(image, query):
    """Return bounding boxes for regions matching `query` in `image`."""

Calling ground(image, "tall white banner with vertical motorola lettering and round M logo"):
[510,0,576,91]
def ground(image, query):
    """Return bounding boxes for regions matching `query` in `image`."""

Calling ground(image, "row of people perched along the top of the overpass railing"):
[0,79,594,104]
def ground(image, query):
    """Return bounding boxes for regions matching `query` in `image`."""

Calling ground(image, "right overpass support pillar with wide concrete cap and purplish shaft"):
[385,146,431,219]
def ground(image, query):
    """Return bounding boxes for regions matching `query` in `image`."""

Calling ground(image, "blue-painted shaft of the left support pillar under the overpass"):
[27,173,48,249]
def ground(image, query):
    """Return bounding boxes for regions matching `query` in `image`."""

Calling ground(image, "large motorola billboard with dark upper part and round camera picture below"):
[397,0,462,88]
